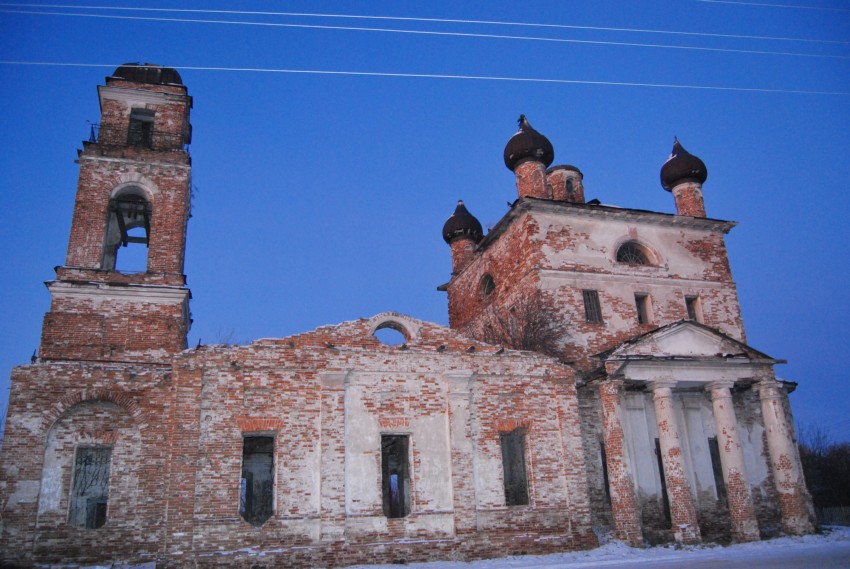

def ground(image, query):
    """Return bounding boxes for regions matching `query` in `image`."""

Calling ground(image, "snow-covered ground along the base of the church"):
[350,526,850,569]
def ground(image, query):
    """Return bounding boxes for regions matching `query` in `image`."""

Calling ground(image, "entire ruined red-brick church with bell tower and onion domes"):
[0,64,813,567]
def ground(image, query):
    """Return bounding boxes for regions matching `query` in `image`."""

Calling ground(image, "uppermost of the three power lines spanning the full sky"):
[0,2,850,45]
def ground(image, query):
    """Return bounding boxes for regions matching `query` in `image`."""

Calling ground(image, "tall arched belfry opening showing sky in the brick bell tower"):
[101,190,151,273]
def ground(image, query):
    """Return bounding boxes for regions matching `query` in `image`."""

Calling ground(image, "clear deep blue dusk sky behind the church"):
[0,0,850,440]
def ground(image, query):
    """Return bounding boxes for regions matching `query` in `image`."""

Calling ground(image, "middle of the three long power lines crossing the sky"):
[0,10,850,59]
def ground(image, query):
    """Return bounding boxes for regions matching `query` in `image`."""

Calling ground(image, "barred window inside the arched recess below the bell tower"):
[68,446,112,529]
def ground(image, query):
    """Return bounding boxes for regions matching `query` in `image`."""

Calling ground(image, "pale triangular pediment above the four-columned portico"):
[600,320,773,361]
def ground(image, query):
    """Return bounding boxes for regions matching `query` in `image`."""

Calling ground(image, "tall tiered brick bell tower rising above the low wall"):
[39,63,192,363]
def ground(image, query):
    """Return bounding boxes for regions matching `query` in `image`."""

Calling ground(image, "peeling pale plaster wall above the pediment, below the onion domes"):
[533,210,744,369]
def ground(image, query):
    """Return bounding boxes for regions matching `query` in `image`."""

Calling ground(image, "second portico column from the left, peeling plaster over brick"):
[650,381,701,543]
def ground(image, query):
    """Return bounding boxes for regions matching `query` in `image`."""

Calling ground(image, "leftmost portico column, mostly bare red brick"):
[599,380,643,547]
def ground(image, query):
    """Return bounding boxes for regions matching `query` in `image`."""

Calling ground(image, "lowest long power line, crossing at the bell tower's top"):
[0,61,850,97]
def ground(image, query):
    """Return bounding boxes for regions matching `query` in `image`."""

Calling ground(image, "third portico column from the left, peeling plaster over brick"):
[706,381,759,541]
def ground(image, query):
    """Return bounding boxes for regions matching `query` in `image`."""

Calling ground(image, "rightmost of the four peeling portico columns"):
[756,378,814,535]
